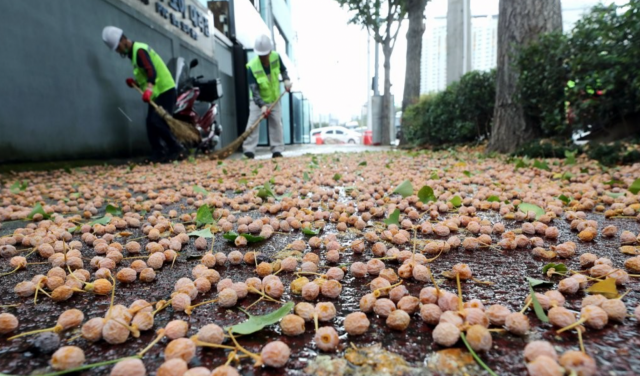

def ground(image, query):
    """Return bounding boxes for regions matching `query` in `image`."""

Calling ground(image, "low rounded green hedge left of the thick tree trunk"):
[402,70,496,145]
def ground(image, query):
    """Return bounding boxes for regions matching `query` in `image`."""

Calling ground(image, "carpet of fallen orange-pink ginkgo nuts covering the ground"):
[0,149,640,376]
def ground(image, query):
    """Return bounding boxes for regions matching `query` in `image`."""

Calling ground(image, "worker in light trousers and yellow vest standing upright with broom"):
[242,35,291,159]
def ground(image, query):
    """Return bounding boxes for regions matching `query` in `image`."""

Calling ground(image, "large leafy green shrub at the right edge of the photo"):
[566,0,640,130]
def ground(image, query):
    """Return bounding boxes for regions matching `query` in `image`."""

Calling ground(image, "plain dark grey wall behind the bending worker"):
[0,0,225,163]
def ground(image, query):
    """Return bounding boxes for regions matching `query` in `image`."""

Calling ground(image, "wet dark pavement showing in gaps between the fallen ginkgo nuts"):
[0,151,640,376]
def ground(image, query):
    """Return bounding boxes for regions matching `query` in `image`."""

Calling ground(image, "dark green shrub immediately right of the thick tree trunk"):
[515,33,571,137]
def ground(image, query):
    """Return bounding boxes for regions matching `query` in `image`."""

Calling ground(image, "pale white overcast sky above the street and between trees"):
[291,0,624,122]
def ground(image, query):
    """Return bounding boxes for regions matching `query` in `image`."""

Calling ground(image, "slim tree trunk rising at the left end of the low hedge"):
[400,0,428,145]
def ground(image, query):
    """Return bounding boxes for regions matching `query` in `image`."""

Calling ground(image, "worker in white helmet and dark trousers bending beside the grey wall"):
[102,26,186,162]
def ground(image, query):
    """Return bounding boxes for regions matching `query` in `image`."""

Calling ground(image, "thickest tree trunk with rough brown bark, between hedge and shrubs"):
[487,0,562,153]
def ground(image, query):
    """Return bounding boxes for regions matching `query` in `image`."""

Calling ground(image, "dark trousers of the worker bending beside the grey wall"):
[147,89,182,156]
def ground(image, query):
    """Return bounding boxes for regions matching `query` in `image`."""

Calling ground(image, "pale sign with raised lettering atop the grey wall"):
[122,0,213,55]
